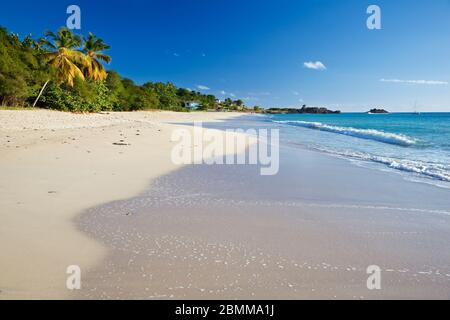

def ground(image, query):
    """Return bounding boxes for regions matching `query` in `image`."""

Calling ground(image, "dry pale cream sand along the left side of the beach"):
[0,110,244,299]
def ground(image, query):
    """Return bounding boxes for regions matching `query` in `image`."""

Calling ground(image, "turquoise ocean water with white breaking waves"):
[267,113,450,188]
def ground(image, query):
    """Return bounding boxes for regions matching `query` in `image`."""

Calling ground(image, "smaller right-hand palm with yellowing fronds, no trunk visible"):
[83,32,111,81]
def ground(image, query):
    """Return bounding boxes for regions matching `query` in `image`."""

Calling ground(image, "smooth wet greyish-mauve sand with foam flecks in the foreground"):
[71,120,450,299]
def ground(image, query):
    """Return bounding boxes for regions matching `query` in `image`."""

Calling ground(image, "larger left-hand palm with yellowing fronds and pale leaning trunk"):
[33,27,84,107]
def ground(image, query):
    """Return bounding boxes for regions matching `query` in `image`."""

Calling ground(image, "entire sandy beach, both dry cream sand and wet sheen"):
[0,111,450,299]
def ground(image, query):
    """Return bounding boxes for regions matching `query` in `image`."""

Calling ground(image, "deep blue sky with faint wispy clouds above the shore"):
[0,0,450,112]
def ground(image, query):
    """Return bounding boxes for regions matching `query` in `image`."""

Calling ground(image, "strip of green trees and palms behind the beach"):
[0,27,261,112]
